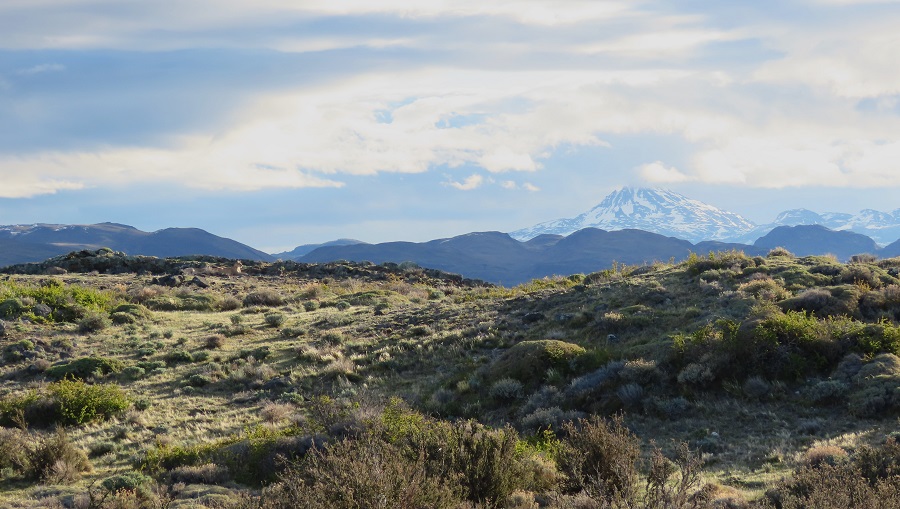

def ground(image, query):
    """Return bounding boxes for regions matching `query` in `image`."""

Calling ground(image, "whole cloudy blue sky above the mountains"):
[0,0,900,252]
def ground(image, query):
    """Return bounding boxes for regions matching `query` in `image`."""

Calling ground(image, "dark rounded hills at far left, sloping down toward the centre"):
[0,223,275,266]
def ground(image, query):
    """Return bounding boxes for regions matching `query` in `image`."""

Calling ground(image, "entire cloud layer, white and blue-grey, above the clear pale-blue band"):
[0,0,900,196]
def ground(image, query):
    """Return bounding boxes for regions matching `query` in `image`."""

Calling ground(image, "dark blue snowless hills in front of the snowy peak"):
[295,225,900,285]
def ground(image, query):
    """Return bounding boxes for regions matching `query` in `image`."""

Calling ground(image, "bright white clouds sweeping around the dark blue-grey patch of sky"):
[0,0,900,196]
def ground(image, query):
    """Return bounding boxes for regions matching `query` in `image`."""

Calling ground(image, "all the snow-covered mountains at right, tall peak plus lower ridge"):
[510,187,900,245]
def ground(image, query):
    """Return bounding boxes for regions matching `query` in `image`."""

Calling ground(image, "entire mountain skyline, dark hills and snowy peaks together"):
[0,188,900,285]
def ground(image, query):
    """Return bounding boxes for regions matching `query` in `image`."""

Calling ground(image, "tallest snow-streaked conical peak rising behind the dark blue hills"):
[510,187,756,242]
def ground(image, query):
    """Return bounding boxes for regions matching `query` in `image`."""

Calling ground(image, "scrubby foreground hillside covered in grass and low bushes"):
[0,248,900,508]
